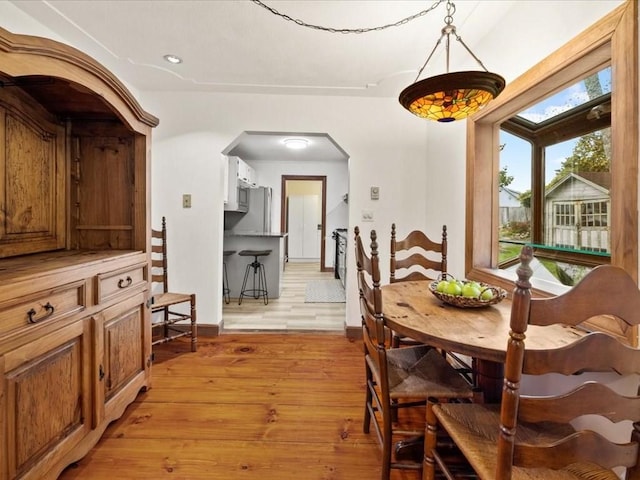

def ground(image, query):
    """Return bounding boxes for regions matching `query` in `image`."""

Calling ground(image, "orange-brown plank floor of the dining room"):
[59,333,424,480]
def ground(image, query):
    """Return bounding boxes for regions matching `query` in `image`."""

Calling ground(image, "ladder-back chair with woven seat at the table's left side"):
[355,227,473,480]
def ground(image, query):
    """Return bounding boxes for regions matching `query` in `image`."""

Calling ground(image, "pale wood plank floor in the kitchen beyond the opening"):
[222,262,346,332]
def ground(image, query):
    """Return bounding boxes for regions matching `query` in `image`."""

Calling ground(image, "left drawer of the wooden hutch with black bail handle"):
[0,280,86,334]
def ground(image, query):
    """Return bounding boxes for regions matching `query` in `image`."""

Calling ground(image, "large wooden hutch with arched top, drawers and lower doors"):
[0,28,158,480]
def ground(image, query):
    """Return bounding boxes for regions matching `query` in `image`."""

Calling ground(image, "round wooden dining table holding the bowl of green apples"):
[382,280,586,403]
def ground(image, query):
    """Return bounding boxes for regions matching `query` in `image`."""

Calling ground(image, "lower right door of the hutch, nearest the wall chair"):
[93,293,151,425]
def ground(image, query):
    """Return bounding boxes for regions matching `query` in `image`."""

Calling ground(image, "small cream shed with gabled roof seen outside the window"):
[545,172,611,252]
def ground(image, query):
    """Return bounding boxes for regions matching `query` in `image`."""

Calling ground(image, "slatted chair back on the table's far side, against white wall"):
[389,223,447,283]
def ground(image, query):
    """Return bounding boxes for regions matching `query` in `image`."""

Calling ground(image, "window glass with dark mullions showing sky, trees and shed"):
[498,71,611,286]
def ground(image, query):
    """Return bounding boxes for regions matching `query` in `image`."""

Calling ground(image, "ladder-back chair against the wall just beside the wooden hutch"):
[151,217,198,352]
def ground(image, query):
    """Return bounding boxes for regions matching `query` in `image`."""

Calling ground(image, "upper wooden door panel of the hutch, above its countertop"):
[0,100,66,258]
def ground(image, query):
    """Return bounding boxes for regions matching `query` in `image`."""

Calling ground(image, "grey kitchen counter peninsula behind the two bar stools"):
[221,230,287,305]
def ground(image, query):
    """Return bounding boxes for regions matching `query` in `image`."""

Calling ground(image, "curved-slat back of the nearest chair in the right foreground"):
[496,246,640,479]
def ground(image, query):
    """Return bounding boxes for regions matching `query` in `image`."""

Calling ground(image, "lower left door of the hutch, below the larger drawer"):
[0,319,91,479]
